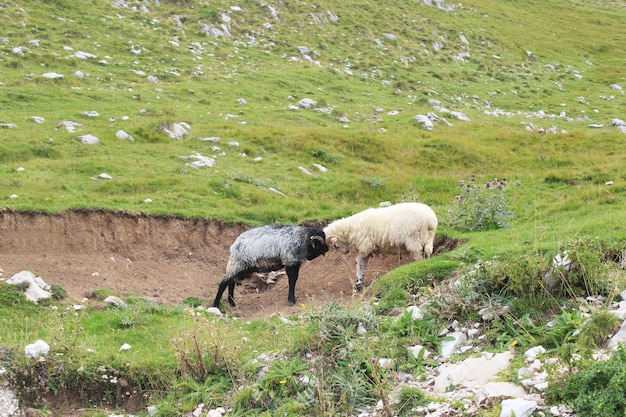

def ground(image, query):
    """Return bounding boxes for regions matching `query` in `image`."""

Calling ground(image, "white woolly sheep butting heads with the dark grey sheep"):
[324,203,438,291]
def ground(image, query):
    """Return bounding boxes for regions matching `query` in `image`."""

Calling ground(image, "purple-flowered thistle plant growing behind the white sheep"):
[449,175,515,232]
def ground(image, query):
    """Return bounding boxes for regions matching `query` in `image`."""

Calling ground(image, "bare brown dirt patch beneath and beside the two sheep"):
[0,209,458,318]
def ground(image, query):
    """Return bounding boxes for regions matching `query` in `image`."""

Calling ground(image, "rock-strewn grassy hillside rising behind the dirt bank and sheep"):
[0,1,626,228]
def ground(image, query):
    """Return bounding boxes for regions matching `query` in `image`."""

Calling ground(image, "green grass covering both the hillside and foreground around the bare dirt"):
[0,0,626,415]
